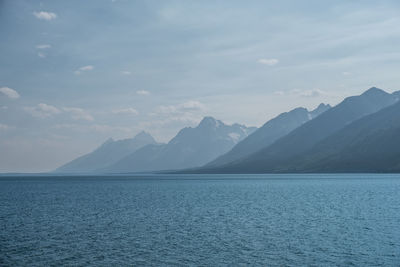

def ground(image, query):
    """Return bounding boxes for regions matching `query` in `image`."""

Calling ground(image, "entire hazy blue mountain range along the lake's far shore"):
[57,87,400,173]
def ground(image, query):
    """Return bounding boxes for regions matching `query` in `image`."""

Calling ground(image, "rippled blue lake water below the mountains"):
[0,175,400,266]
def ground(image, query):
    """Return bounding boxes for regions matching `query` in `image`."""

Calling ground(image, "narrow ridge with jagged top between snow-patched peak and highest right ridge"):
[206,103,331,167]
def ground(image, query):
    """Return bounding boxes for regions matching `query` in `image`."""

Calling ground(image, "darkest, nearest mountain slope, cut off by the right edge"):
[268,100,400,173]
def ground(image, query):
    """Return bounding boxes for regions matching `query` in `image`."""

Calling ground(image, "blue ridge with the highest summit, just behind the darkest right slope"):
[193,87,398,173]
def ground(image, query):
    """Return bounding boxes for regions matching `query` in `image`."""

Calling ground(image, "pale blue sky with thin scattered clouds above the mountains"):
[0,0,400,172]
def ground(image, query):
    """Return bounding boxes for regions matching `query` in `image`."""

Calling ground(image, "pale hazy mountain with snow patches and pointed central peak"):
[103,117,256,172]
